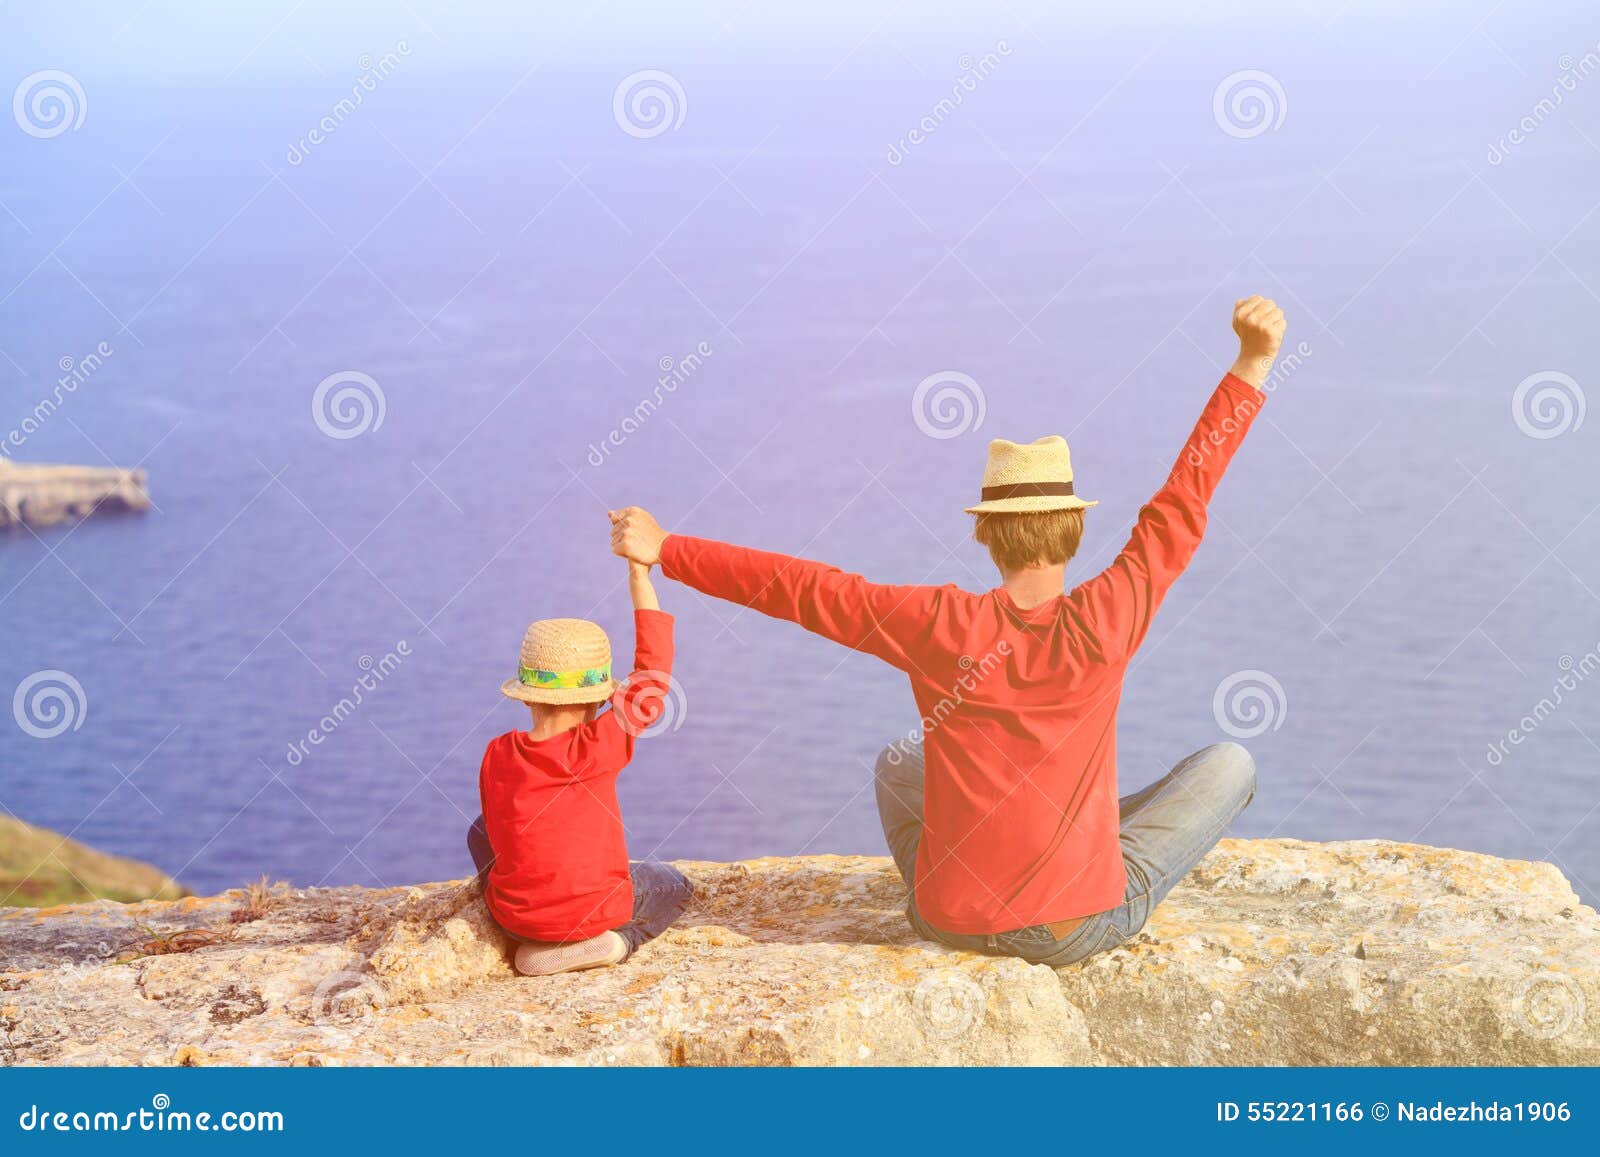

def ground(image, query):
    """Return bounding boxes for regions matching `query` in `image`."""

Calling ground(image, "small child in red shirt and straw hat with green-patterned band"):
[467,563,690,976]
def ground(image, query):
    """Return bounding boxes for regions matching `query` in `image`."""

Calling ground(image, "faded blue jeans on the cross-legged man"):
[877,741,1256,967]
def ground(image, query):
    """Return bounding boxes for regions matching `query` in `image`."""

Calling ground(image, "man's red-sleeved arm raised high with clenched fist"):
[1077,296,1285,656]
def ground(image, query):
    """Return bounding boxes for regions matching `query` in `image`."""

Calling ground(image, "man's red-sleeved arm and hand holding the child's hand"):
[611,506,946,669]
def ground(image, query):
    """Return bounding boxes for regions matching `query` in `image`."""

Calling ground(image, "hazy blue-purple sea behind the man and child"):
[0,5,1600,899]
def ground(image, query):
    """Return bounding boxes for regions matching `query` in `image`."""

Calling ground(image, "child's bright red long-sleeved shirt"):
[478,611,672,941]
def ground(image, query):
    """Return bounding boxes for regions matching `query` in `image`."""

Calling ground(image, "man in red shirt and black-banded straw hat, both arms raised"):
[611,296,1285,965]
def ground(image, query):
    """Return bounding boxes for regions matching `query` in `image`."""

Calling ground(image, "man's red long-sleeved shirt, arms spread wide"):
[661,374,1266,935]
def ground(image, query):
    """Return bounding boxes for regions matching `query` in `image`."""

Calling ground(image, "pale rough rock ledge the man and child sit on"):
[0,840,1600,1066]
